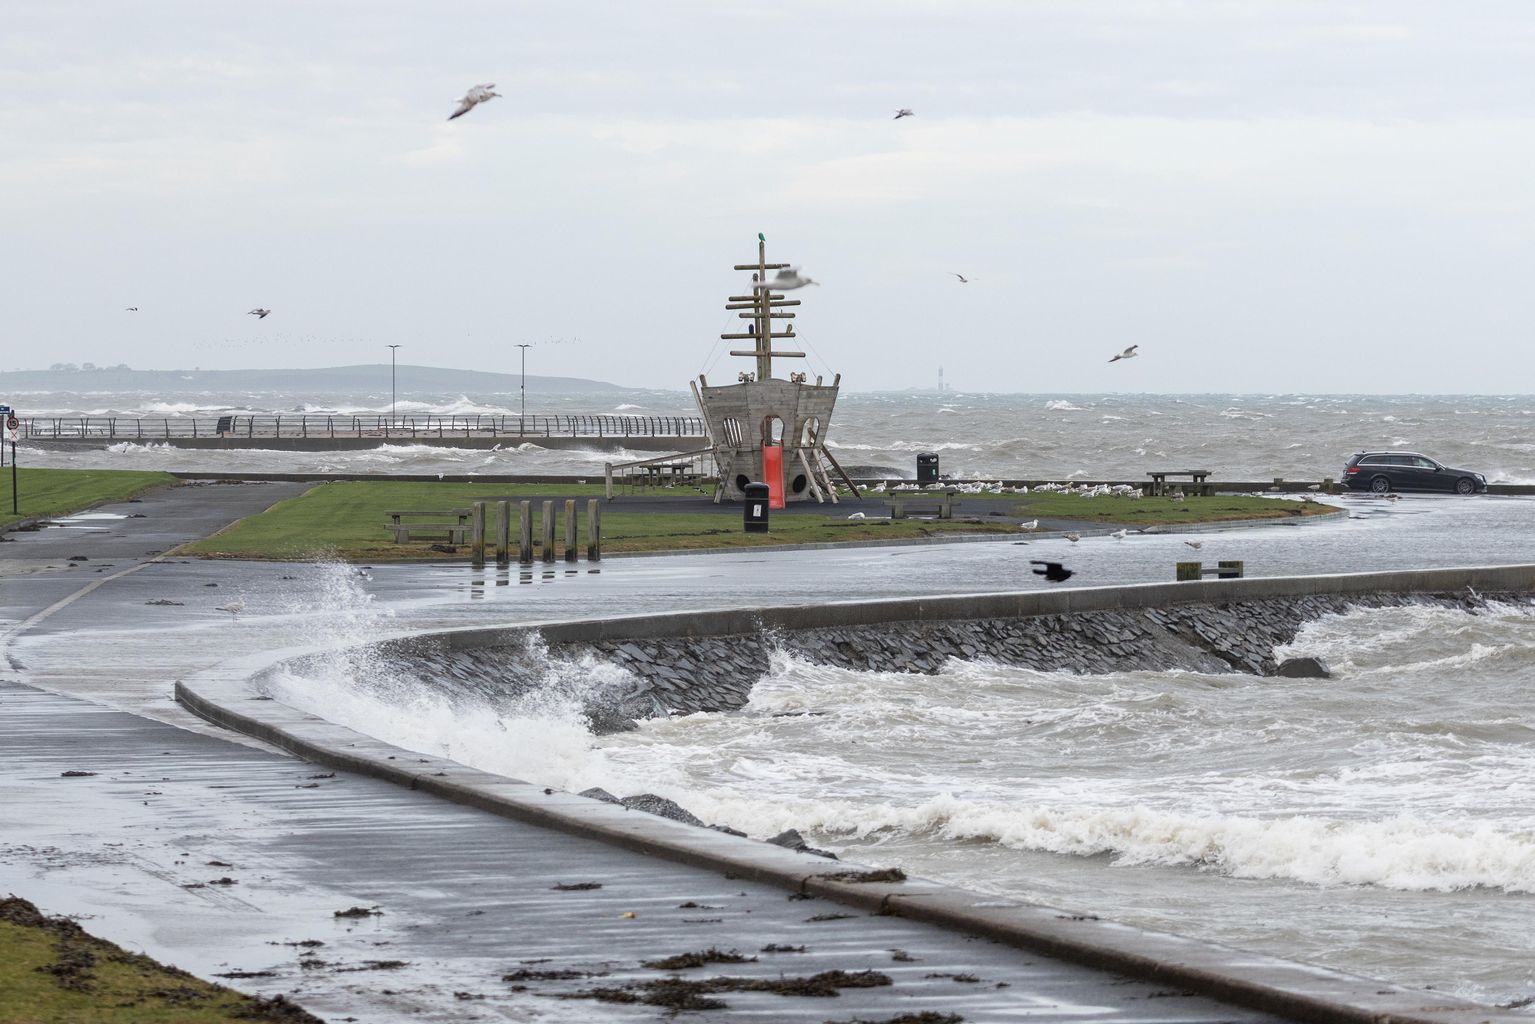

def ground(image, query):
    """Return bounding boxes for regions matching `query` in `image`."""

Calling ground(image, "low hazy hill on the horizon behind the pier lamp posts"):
[0,362,628,396]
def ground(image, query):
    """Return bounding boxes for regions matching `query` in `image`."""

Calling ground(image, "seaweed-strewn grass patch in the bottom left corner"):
[0,897,319,1024]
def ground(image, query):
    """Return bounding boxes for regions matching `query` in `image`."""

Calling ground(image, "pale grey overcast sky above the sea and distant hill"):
[0,0,1535,393]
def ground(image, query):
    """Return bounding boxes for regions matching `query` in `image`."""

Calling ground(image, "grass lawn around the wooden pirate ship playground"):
[181,481,1326,562]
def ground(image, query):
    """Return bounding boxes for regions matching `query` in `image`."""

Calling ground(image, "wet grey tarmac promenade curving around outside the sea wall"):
[0,484,1535,1021]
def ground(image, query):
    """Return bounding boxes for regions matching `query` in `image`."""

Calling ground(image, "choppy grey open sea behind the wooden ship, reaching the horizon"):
[12,391,1535,484]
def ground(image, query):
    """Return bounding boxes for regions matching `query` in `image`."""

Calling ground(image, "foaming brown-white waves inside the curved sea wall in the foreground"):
[276,595,1535,1003]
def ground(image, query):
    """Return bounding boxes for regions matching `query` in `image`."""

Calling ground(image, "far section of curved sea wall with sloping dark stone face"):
[388,567,1535,732]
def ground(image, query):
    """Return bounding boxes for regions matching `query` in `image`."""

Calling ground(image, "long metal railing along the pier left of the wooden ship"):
[20,413,705,441]
